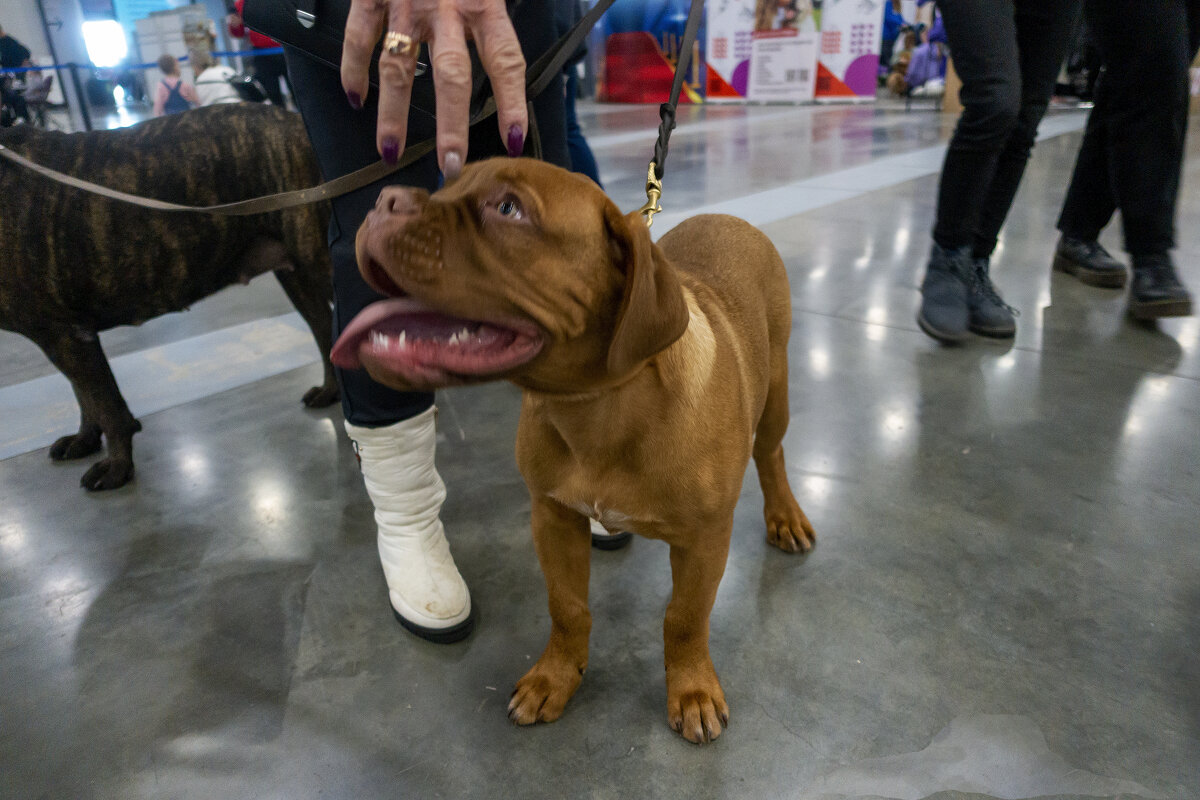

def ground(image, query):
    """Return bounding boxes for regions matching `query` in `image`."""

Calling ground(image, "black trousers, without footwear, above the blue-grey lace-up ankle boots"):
[934,0,1079,249]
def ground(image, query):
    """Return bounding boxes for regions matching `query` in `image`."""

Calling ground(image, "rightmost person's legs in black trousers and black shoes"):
[1055,0,1200,319]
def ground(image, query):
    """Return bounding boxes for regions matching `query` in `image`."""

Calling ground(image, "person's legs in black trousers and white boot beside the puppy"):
[287,0,569,642]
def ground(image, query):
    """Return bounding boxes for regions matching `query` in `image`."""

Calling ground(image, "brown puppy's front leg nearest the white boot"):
[509,498,592,724]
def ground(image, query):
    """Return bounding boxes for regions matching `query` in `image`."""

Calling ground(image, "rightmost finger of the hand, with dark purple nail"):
[472,4,529,156]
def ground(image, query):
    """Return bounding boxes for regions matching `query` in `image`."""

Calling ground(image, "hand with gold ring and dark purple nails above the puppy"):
[342,0,529,178]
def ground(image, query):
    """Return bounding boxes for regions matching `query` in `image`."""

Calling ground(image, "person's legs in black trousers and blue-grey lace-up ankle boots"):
[917,0,1079,342]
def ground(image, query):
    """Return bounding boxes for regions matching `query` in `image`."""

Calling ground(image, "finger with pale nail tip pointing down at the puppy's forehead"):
[430,10,470,180]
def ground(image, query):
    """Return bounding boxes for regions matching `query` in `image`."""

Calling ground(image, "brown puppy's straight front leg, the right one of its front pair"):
[662,527,733,744]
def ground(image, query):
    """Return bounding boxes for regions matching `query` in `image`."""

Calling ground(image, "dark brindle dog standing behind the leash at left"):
[0,103,337,489]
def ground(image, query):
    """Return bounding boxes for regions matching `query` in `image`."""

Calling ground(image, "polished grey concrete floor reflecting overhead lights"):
[0,100,1200,800]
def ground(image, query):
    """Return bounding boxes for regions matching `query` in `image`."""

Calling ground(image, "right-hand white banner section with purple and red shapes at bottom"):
[816,0,886,100]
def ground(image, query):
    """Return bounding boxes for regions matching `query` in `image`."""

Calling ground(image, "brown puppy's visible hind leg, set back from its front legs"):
[754,352,816,553]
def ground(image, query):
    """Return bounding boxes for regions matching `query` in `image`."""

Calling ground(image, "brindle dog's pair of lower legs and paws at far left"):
[30,330,142,491]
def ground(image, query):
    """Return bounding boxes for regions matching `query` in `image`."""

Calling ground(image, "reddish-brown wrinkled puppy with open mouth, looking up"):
[334,158,814,742]
